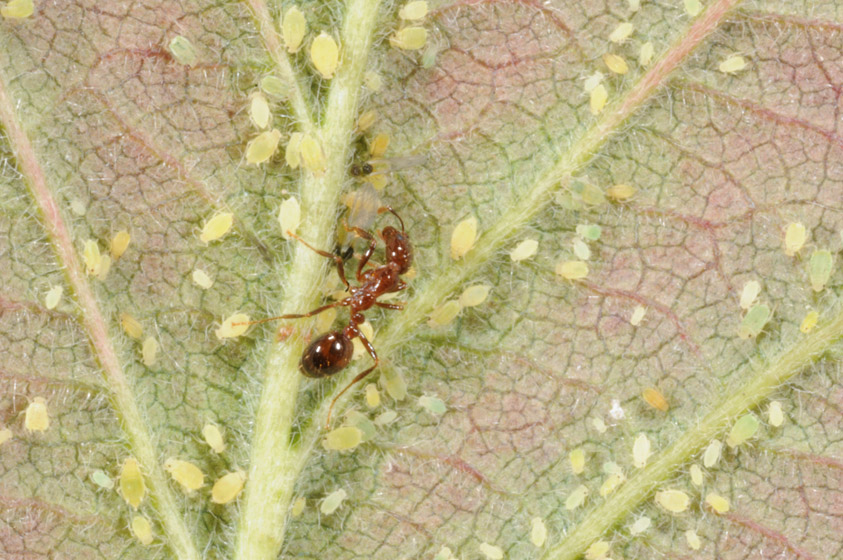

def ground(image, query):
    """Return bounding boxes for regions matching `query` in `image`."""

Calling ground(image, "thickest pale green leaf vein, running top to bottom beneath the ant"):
[236,0,379,560]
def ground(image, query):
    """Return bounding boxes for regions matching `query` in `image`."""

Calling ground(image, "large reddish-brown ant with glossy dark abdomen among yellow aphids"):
[250,206,413,429]
